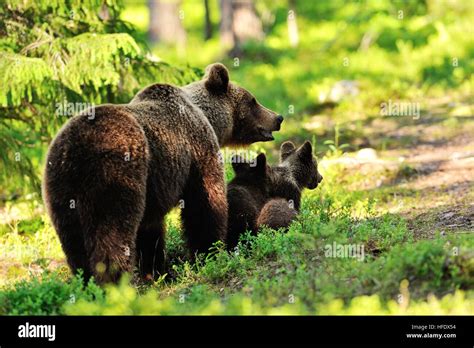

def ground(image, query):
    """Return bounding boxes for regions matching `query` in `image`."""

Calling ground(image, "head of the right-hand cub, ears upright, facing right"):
[277,141,323,190]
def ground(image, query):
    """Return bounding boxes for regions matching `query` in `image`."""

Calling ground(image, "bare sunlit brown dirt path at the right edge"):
[392,133,474,237]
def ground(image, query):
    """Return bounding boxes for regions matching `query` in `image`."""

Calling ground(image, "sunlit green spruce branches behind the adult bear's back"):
[0,0,202,194]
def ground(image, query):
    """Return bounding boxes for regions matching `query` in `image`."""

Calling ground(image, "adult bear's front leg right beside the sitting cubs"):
[181,155,227,255]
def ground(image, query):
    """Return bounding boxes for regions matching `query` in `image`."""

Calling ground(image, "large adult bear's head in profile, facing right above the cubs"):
[185,63,283,146]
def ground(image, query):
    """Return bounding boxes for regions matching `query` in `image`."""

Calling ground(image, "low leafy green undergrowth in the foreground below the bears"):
[0,205,474,315]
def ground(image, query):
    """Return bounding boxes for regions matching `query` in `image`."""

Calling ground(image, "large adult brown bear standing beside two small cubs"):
[43,64,283,283]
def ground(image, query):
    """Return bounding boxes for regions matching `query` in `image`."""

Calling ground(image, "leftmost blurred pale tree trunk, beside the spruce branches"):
[148,0,186,46]
